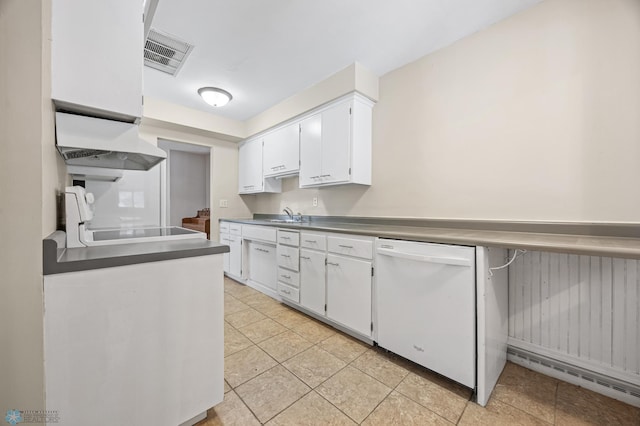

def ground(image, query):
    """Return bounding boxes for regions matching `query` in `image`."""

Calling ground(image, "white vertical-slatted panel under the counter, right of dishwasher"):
[509,252,640,382]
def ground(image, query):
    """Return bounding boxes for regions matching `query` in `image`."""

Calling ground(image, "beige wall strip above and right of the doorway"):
[140,122,254,241]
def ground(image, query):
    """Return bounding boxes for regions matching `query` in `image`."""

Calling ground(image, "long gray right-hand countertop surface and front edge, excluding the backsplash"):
[221,218,640,259]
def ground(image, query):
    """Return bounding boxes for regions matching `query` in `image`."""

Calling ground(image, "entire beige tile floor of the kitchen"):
[198,278,640,426]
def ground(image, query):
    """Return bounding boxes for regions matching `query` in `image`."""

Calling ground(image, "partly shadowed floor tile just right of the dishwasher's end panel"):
[492,362,558,423]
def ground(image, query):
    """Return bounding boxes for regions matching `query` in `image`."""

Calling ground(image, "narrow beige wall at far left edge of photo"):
[0,0,64,416]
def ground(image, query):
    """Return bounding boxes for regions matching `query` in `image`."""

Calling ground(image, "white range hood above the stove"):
[56,112,167,170]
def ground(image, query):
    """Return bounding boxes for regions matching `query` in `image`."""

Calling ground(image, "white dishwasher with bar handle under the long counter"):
[375,239,476,388]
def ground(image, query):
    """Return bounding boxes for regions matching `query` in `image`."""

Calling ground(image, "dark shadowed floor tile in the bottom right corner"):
[555,382,640,426]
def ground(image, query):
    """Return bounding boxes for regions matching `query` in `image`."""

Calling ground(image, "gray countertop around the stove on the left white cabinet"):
[42,231,229,275]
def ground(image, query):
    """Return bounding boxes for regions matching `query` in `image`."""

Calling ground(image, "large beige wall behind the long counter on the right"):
[253,0,640,222]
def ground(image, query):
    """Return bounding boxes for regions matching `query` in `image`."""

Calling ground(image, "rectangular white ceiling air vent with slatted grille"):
[144,28,193,75]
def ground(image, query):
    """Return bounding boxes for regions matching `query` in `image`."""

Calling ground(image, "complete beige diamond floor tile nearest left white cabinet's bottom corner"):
[236,365,310,423]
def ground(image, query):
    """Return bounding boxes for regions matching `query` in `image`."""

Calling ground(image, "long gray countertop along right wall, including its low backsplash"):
[221,215,640,259]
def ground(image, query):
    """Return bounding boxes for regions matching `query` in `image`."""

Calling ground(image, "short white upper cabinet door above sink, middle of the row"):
[264,123,300,177]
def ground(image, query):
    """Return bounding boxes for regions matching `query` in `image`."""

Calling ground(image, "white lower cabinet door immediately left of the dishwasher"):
[327,254,371,336]
